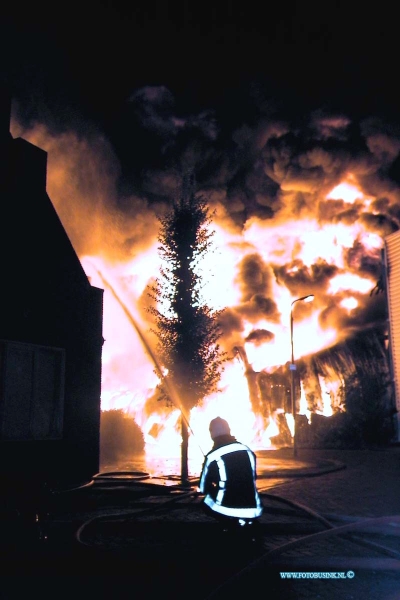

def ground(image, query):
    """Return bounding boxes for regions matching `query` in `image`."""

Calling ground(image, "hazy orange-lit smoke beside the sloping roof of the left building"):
[11,120,158,260]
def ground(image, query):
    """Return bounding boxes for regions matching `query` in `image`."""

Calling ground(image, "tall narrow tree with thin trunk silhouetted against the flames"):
[149,175,226,483]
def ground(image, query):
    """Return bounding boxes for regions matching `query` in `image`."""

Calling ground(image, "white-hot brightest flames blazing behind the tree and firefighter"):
[81,172,380,473]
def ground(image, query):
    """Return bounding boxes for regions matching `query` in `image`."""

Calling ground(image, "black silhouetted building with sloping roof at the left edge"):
[0,94,103,488]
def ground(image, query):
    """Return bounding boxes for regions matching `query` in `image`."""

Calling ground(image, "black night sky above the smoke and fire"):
[1,1,399,195]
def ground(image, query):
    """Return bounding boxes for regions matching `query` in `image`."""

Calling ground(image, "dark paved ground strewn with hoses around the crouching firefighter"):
[0,447,400,600]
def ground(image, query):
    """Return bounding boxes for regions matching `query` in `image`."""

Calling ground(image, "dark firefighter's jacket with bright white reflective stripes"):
[199,436,262,519]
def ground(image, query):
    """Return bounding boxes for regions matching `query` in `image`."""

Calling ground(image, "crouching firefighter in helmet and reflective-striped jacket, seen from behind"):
[199,417,263,531]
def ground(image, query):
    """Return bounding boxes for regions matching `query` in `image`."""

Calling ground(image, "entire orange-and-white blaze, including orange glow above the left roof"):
[10,118,389,473]
